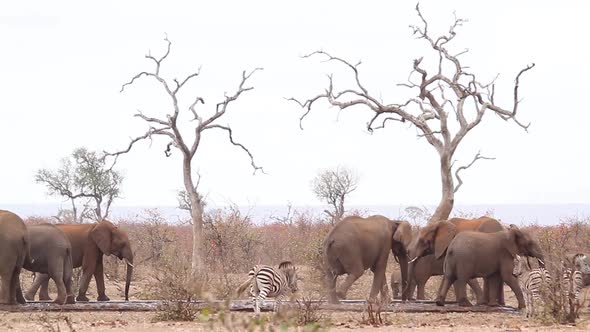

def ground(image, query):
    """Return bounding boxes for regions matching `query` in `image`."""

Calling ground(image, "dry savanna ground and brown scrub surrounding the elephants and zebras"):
[6,208,590,331]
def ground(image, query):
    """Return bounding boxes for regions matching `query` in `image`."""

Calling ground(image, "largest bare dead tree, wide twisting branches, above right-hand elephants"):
[289,5,535,221]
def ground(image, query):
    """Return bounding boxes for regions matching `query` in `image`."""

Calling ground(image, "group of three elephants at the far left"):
[0,210,133,304]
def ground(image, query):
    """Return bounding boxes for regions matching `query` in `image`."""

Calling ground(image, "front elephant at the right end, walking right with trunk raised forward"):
[436,225,545,309]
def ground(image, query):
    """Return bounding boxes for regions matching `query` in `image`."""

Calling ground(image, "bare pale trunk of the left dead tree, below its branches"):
[182,156,206,278]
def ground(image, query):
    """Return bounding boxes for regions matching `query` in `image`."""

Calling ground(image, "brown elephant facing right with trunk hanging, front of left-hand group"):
[27,220,134,302]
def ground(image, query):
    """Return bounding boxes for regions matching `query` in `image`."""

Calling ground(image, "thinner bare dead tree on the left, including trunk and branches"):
[108,37,263,276]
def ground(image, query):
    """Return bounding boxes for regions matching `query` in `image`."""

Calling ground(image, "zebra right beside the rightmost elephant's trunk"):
[512,255,551,317]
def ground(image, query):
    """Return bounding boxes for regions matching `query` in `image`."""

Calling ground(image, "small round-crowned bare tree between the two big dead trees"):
[312,167,358,225]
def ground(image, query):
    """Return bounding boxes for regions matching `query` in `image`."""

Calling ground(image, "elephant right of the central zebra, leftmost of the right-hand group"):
[323,216,412,303]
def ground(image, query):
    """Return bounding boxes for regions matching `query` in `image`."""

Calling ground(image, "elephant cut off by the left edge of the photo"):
[0,210,30,304]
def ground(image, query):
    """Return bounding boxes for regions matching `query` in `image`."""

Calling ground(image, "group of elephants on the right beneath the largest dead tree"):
[322,216,572,309]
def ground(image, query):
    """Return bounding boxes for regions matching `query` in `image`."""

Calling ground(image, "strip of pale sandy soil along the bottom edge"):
[0,312,590,332]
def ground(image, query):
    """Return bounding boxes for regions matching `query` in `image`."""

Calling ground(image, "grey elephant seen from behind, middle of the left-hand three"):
[23,224,74,304]
